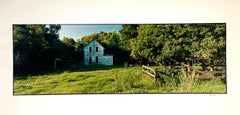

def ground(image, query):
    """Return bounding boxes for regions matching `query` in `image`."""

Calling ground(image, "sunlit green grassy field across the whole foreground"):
[14,65,226,95]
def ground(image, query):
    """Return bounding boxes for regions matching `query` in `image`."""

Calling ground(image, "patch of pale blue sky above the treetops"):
[59,24,121,41]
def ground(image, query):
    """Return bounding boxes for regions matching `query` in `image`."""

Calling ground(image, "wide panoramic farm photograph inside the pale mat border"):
[12,23,227,95]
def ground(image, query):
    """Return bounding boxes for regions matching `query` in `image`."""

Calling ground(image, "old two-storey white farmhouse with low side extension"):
[83,39,113,65]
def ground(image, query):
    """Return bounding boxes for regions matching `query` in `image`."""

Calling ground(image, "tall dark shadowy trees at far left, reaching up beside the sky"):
[13,24,60,74]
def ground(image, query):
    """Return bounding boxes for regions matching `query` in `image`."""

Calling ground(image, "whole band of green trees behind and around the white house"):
[13,23,226,75]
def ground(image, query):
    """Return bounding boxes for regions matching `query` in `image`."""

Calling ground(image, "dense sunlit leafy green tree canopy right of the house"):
[130,24,226,65]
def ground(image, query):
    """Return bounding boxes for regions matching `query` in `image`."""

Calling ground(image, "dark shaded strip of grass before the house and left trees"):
[13,64,124,80]
